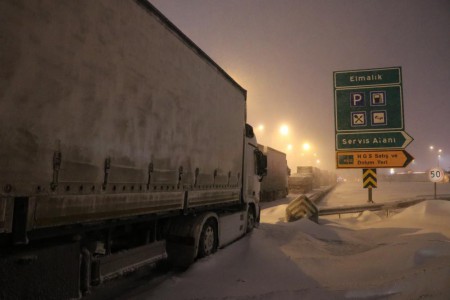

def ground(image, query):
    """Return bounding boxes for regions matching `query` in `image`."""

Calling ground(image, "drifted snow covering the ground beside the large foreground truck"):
[129,200,450,299]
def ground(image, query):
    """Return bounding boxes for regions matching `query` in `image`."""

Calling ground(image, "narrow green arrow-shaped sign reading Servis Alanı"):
[336,131,413,150]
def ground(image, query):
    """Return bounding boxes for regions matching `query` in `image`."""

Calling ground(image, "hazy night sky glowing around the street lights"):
[150,0,450,174]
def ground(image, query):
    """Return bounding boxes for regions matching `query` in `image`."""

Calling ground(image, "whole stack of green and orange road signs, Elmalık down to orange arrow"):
[333,67,413,169]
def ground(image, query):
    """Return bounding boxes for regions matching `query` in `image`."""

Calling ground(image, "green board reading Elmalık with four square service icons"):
[334,67,404,132]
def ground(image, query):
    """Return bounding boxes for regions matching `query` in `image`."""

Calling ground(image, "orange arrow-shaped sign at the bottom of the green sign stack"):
[336,150,414,169]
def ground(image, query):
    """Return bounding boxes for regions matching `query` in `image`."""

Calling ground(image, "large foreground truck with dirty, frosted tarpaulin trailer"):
[0,0,266,299]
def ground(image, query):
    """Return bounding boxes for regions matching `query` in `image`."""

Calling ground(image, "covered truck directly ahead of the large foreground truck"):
[258,145,289,201]
